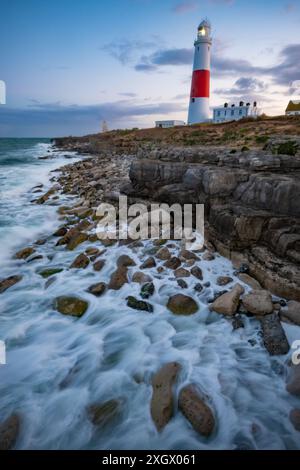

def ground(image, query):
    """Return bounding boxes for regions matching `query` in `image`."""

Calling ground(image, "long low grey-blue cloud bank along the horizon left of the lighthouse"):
[0,100,186,137]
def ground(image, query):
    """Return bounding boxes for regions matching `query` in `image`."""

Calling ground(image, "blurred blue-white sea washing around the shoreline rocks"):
[0,139,300,450]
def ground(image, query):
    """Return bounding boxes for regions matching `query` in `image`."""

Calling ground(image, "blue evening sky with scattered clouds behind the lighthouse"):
[0,0,300,137]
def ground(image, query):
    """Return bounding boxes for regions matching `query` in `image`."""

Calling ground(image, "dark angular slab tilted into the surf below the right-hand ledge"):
[261,313,290,356]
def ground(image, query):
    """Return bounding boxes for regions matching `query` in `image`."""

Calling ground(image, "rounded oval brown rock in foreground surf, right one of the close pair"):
[178,385,215,437]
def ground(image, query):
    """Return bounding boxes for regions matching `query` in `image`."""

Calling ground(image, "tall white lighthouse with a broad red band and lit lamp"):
[188,20,212,124]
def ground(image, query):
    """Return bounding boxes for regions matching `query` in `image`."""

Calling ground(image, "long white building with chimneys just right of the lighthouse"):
[213,101,261,123]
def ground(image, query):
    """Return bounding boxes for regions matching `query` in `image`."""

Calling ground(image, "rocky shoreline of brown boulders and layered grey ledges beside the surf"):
[0,134,300,449]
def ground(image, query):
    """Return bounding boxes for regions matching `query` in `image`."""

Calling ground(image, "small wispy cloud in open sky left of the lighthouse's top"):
[101,39,157,65]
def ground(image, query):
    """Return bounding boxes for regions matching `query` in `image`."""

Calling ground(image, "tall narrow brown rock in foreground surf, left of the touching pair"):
[150,362,181,431]
